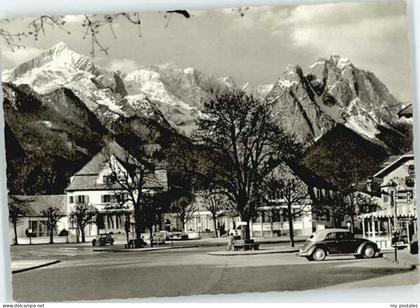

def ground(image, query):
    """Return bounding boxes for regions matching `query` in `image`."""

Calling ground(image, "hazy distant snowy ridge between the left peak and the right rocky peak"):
[121,65,236,135]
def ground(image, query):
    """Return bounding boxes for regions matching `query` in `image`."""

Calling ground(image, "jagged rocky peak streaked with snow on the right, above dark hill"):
[266,56,402,143]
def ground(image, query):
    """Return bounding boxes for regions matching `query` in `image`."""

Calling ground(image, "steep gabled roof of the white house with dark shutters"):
[66,141,167,191]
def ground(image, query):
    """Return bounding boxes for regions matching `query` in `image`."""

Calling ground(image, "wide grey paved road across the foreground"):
[13,247,418,302]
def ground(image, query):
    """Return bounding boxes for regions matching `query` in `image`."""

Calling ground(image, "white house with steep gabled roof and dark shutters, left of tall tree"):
[65,141,168,242]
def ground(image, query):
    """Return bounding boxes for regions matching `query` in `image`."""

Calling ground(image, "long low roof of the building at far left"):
[11,195,67,216]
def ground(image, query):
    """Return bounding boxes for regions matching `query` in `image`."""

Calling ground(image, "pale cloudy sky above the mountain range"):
[1,0,411,102]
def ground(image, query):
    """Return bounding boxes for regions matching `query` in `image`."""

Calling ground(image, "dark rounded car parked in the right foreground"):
[299,229,380,261]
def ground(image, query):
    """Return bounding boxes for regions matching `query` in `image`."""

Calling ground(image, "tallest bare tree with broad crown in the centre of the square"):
[195,92,301,239]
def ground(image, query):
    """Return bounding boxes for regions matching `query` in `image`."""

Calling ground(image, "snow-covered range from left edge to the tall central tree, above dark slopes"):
[2,42,236,135]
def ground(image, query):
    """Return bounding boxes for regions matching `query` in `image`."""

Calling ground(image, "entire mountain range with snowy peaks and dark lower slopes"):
[2,43,412,193]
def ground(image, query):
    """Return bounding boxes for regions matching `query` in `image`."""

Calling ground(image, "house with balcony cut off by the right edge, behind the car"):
[359,152,417,249]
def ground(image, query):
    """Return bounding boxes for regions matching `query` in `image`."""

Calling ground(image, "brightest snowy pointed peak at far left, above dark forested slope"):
[2,42,166,124]
